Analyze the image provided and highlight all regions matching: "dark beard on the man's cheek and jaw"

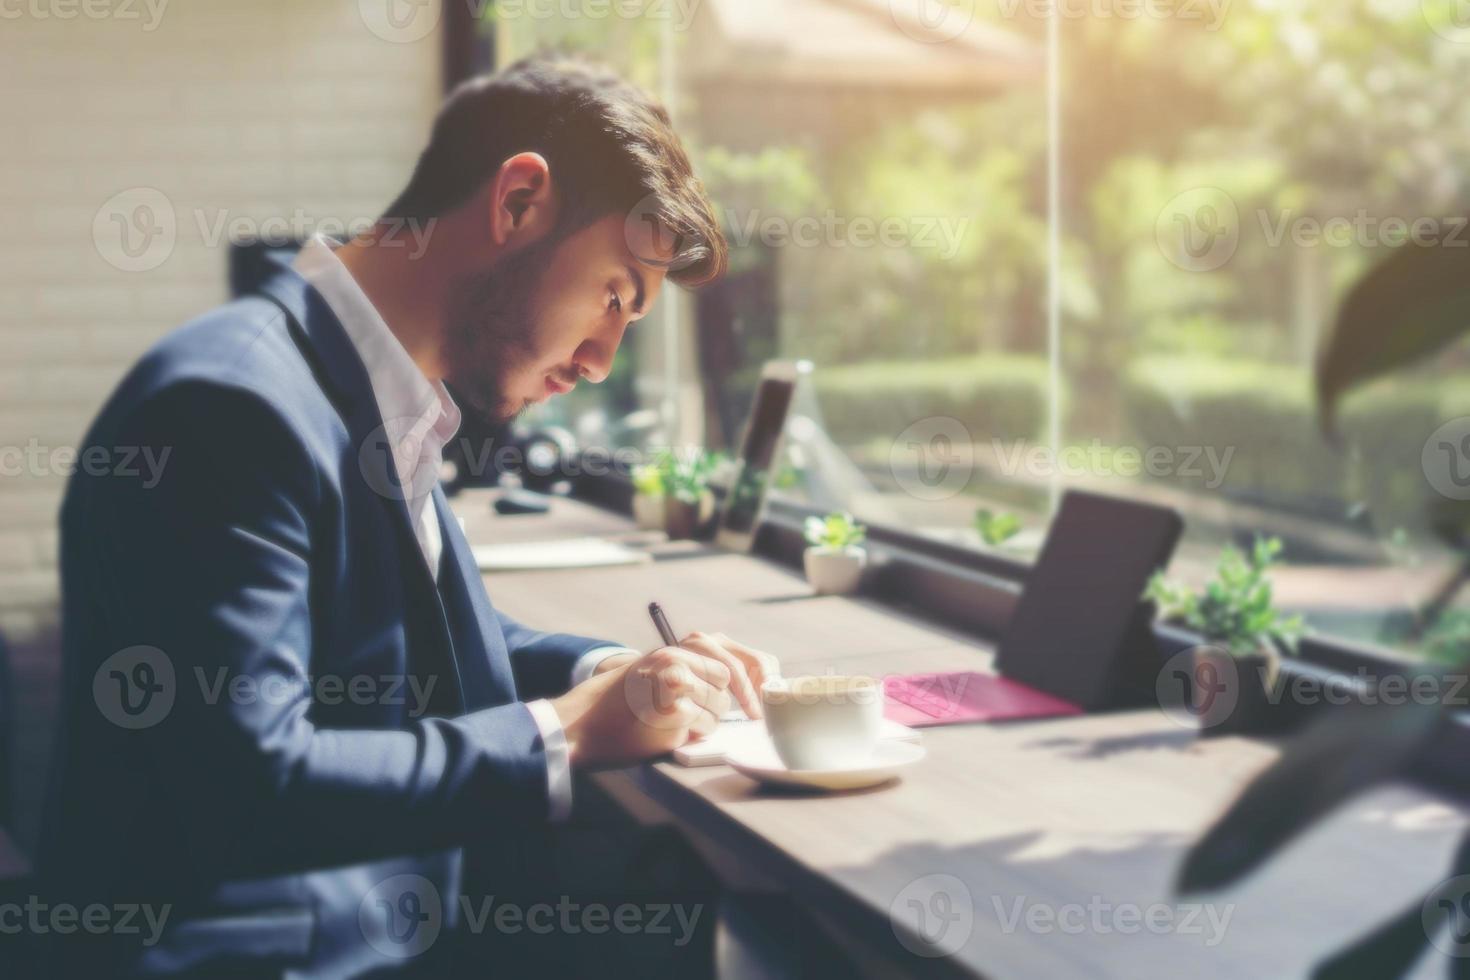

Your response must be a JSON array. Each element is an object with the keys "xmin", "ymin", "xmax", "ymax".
[{"xmin": 445, "ymin": 239, "xmax": 556, "ymax": 425}]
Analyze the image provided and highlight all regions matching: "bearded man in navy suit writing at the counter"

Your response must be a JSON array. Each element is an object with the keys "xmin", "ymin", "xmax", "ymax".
[{"xmin": 41, "ymin": 63, "xmax": 773, "ymax": 977}]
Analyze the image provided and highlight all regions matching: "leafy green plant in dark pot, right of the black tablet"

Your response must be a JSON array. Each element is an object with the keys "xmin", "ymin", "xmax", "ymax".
[{"xmin": 1145, "ymin": 538, "xmax": 1302, "ymax": 735}]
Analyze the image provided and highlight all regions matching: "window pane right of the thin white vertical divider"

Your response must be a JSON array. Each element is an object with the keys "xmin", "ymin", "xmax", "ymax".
[{"xmin": 1060, "ymin": 0, "xmax": 1470, "ymax": 664}]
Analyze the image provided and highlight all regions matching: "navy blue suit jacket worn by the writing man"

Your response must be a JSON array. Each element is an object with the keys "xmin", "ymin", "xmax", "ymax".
[{"xmin": 41, "ymin": 262, "xmax": 604, "ymax": 977}]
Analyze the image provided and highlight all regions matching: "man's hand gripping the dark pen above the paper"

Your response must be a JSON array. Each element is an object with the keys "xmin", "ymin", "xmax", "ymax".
[{"xmin": 551, "ymin": 646, "xmax": 735, "ymax": 767}]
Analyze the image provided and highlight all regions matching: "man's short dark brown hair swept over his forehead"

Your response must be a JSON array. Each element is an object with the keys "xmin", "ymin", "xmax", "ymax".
[{"xmin": 384, "ymin": 59, "xmax": 728, "ymax": 287}]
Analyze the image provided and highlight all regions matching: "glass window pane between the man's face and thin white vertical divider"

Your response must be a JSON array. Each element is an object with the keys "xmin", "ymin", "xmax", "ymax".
[{"xmin": 681, "ymin": 0, "xmax": 1048, "ymax": 554}]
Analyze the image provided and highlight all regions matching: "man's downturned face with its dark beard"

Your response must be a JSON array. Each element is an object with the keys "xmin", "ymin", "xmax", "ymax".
[{"xmin": 435, "ymin": 215, "xmax": 664, "ymax": 422}]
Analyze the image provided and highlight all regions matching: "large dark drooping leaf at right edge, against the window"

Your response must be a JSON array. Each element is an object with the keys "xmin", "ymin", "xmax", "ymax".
[{"xmin": 1317, "ymin": 232, "xmax": 1470, "ymax": 435}]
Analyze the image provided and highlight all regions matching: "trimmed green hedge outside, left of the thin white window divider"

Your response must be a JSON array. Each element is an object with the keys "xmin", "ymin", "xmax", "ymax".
[{"xmin": 814, "ymin": 354, "xmax": 1047, "ymax": 445}]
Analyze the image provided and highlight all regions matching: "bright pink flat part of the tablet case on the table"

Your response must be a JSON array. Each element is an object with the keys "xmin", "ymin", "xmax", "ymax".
[{"xmin": 883, "ymin": 670, "xmax": 1082, "ymax": 729}]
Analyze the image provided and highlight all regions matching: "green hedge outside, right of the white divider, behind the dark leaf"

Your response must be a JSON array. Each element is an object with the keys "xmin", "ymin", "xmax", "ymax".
[{"xmin": 1123, "ymin": 357, "xmax": 1467, "ymax": 527}]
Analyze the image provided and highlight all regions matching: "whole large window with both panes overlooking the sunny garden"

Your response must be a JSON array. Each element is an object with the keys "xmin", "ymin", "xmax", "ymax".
[{"xmin": 488, "ymin": 0, "xmax": 1470, "ymax": 664}]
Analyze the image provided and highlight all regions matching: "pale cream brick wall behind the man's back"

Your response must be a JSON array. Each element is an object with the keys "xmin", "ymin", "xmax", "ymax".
[{"xmin": 0, "ymin": 0, "xmax": 441, "ymax": 840}]
